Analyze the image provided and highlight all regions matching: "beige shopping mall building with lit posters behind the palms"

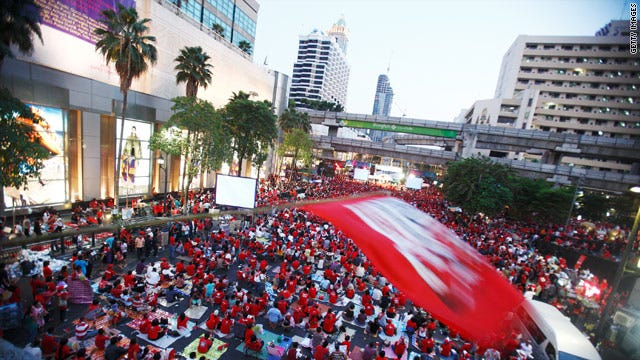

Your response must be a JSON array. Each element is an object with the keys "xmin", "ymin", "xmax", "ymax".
[{"xmin": 1, "ymin": 0, "xmax": 289, "ymax": 208}]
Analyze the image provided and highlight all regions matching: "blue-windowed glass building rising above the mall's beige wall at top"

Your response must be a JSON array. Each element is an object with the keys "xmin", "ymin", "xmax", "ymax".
[{"xmin": 169, "ymin": 0, "xmax": 260, "ymax": 52}]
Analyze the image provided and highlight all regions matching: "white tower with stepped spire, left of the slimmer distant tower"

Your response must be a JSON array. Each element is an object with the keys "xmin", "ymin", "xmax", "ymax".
[{"xmin": 289, "ymin": 18, "xmax": 349, "ymax": 106}]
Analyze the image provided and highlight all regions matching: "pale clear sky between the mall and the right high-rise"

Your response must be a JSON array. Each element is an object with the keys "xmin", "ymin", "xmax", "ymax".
[{"xmin": 254, "ymin": 0, "xmax": 630, "ymax": 121}]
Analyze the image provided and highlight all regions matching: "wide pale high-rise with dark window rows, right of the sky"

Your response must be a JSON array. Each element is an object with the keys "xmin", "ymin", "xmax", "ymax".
[{"xmin": 463, "ymin": 21, "xmax": 640, "ymax": 172}]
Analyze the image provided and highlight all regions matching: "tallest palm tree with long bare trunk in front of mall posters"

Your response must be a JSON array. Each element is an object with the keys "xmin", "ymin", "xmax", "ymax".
[{"xmin": 93, "ymin": 3, "xmax": 158, "ymax": 202}]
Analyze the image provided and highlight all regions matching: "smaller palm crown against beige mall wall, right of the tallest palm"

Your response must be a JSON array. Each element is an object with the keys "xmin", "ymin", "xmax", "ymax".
[{"xmin": 175, "ymin": 46, "xmax": 213, "ymax": 97}]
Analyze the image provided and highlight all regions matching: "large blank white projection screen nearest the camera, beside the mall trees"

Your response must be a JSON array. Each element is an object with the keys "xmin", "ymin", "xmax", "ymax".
[{"xmin": 216, "ymin": 174, "xmax": 256, "ymax": 209}]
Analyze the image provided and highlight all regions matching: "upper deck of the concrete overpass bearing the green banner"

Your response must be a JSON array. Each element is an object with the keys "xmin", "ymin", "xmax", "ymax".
[{"xmin": 300, "ymin": 109, "xmax": 640, "ymax": 162}]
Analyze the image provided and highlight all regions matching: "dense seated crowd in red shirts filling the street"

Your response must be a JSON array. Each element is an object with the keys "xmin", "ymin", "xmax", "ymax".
[{"xmin": 0, "ymin": 176, "xmax": 632, "ymax": 360}]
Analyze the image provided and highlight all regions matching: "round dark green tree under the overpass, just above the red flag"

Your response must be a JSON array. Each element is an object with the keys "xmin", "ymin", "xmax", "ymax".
[{"xmin": 443, "ymin": 157, "xmax": 514, "ymax": 216}]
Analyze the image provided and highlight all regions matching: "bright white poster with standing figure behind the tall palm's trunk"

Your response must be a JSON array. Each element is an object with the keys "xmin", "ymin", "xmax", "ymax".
[{"xmin": 116, "ymin": 120, "xmax": 151, "ymax": 196}]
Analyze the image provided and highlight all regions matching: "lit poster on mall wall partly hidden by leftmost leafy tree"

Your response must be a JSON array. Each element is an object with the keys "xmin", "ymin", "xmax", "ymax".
[{"xmin": 3, "ymin": 105, "xmax": 68, "ymax": 209}]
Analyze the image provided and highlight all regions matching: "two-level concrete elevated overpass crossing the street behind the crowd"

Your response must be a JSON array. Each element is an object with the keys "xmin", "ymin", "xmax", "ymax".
[{"xmin": 301, "ymin": 109, "xmax": 640, "ymax": 192}]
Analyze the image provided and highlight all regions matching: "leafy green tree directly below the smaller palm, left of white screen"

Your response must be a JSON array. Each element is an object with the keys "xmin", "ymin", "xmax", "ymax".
[{"xmin": 149, "ymin": 96, "xmax": 232, "ymax": 210}]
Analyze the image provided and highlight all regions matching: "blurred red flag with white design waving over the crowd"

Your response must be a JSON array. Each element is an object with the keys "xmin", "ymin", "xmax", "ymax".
[{"xmin": 303, "ymin": 196, "xmax": 523, "ymax": 344}]
